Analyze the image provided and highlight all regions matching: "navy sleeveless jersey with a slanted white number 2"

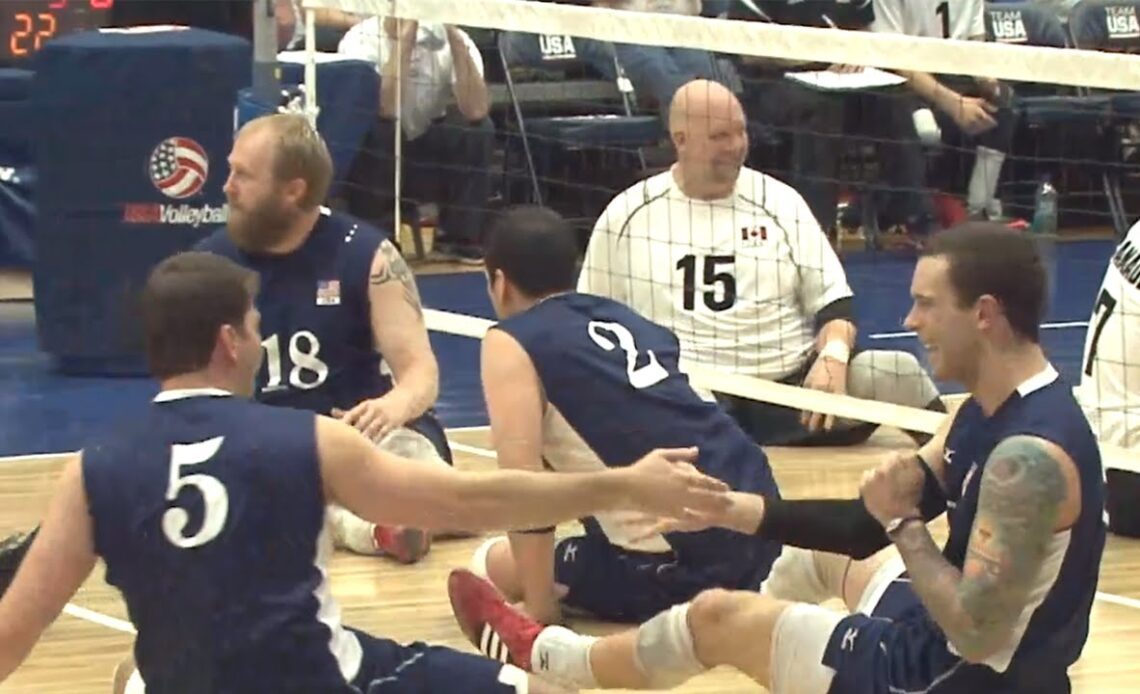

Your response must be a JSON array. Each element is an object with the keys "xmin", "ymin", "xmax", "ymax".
[{"xmin": 497, "ymin": 293, "xmax": 780, "ymax": 580}]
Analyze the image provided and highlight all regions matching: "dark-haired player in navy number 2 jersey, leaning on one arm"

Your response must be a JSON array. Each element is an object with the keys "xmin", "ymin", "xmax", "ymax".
[{"xmin": 473, "ymin": 206, "xmax": 780, "ymax": 622}]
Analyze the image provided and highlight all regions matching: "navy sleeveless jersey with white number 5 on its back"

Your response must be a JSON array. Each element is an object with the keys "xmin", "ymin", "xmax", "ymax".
[{"xmin": 82, "ymin": 390, "xmax": 361, "ymax": 694}]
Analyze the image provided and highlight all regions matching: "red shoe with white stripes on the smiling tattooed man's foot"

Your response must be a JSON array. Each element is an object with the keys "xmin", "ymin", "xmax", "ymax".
[{"xmin": 447, "ymin": 569, "xmax": 544, "ymax": 672}]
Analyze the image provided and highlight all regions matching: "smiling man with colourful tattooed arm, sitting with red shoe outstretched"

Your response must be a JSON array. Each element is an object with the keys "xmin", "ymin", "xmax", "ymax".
[{"xmin": 450, "ymin": 222, "xmax": 1105, "ymax": 694}]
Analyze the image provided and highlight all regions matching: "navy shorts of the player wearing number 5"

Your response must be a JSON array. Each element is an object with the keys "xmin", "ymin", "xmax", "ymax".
[{"xmin": 350, "ymin": 629, "xmax": 515, "ymax": 694}]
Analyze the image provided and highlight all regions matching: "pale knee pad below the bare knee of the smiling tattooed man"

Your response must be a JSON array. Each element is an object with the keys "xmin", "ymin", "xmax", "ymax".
[{"xmin": 634, "ymin": 603, "xmax": 706, "ymax": 689}]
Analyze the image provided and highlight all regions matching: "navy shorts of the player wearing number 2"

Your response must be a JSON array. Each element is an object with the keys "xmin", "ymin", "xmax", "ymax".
[{"xmin": 554, "ymin": 534, "xmax": 738, "ymax": 623}]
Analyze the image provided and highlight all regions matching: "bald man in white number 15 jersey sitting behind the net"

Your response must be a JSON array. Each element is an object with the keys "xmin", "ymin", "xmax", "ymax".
[{"xmin": 578, "ymin": 80, "xmax": 944, "ymax": 446}]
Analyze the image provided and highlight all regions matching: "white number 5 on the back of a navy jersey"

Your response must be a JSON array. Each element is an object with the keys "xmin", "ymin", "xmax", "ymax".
[{"xmin": 162, "ymin": 436, "xmax": 229, "ymax": 549}]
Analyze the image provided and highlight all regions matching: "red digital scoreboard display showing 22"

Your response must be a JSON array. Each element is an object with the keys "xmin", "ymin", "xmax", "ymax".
[{"xmin": 0, "ymin": 0, "xmax": 115, "ymax": 65}]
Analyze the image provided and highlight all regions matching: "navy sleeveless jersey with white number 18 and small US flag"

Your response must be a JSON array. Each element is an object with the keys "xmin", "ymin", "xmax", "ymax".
[{"xmin": 197, "ymin": 209, "xmax": 391, "ymax": 414}]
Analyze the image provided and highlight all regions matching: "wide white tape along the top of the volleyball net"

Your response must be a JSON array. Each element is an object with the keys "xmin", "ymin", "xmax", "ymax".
[{"xmin": 303, "ymin": 0, "xmax": 1140, "ymax": 90}]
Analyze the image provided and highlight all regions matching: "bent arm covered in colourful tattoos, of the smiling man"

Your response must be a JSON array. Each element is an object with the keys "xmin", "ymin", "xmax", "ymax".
[{"xmin": 896, "ymin": 436, "xmax": 1067, "ymax": 662}]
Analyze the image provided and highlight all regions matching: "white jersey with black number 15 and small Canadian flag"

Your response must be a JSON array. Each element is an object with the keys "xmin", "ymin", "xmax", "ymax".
[{"xmin": 578, "ymin": 168, "xmax": 852, "ymax": 378}]
